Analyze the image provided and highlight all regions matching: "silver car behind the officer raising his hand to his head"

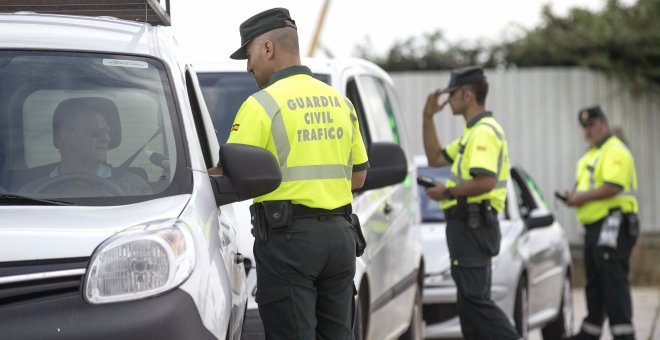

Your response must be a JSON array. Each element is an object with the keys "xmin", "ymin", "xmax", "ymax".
[{"xmin": 415, "ymin": 156, "xmax": 573, "ymax": 340}]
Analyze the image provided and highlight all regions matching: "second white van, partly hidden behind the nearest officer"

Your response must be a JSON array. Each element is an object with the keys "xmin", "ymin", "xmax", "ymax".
[{"xmin": 195, "ymin": 59, "xmax": 424, "ymax": 340}]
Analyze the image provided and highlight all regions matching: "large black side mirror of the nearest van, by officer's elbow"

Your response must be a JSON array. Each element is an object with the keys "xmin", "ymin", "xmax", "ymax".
[{"xmin": 209, "ymin": 144, "xmax": 282, "ymax": 206}]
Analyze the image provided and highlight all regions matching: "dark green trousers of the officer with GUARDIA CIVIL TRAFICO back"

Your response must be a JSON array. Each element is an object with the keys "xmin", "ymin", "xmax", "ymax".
[{"xmin": 254, "ymin": 215, "xmax": 355, "ymax": 340}]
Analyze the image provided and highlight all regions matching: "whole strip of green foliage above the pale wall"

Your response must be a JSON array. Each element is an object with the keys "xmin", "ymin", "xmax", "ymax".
[{"xmin": 357, "ymin": 0, "xmax": 660, "ymax": 90}]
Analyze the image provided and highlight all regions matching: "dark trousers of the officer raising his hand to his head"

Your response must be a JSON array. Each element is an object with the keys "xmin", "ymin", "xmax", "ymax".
[{"xmin": 447, "ymin": 219, "xmax": 520, "ymax": 340}]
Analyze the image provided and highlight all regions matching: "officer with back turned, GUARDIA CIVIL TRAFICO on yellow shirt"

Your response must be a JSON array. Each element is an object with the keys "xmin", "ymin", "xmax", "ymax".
[{"xmin": 219, "ymin": 8, "xmax": 369, "ymax": 340}]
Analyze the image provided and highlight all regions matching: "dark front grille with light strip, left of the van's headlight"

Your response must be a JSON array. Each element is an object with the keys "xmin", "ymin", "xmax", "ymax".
[{"xmin": 0, "ymin": 257, "xmax": 89, "ymax": 306}]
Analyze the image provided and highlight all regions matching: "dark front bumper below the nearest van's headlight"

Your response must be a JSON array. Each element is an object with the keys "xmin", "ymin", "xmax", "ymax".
[{"xmin": 0, "ymin": 289, "xmax": 217, "ymax": 340}]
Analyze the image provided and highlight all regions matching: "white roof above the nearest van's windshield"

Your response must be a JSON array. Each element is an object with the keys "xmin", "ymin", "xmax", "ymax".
[{"xmin": 0, "ymin": 12, "xmax": 166, "ymax": 55}]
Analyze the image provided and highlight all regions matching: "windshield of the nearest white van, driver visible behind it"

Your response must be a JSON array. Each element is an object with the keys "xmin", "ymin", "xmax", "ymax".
[{"xmin": 0, "ymin": 51, "xmax": 191, "ymax": 205}]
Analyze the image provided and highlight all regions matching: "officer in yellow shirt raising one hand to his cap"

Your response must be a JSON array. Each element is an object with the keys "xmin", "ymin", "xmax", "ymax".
[{"xmin": 423, "ymin": 66, "xmax": 520, "ymax": 340}]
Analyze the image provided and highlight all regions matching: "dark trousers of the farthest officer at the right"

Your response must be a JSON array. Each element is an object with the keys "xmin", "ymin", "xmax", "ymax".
[{"xmin": 578, "ymin": 215, "xmax": 638, "ymax": 340}]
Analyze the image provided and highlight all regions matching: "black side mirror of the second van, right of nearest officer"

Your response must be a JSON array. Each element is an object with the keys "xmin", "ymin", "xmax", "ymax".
[{"xmin": 357, "ymin": 142, "xmax": 408, "ymax": 191}]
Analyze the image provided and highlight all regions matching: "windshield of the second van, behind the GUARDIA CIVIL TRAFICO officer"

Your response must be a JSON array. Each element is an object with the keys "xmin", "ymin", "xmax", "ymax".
[{"xmin": 197, "ymin": 72, "xmax": 330, "ymax": 144}]
